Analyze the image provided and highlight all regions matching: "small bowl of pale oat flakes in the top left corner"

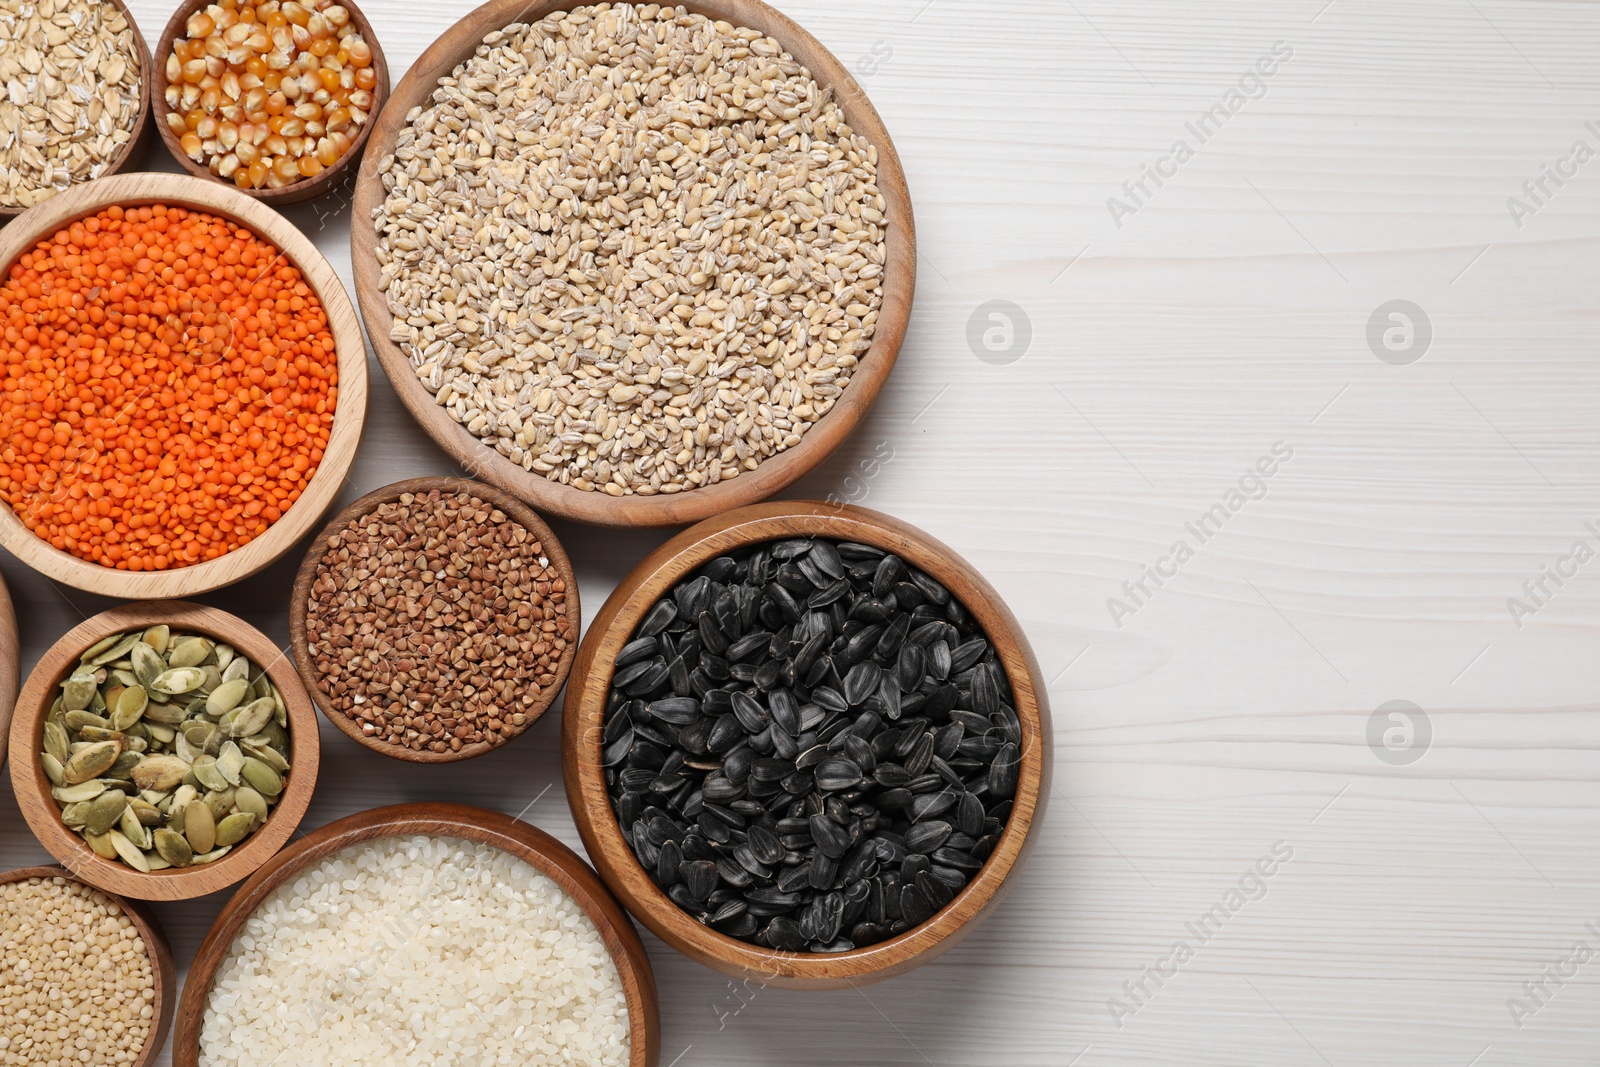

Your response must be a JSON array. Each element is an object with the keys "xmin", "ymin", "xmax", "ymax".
[{"xmin": 0, "ymin": 0, "xmax": 150, "ymax": 226}]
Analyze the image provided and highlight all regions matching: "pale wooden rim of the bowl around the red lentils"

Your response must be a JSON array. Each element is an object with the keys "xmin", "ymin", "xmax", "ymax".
[{"xmin": 0, "ymin": 174, "xmax": 366, "ymax": 600}]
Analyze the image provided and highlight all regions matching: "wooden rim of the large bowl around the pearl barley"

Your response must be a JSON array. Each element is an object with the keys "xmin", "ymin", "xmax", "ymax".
[{"xmin": 350, "ymin": 0, "xmax": 917, "ymax": 526}]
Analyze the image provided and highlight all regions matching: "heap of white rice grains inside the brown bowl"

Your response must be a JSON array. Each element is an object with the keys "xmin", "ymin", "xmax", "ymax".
[{"xmin": 200, "ymin": 837, "xmax": 629, "ymax": 1067}]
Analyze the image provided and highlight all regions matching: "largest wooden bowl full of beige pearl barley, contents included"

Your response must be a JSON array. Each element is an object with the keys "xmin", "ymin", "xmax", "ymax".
[{"xmin": 350, "ymin": 0, "xmax": 915, "ymax": 526}]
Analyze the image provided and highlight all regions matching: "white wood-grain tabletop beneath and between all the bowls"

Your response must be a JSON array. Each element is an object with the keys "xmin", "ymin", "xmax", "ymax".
[{"xmin": 0, "ymin": 0, "xmax": 1600, "ymax": 1067}]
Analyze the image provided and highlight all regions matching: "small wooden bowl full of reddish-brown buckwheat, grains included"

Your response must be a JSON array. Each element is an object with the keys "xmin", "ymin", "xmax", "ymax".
[{"xmin": 290, "ymin": 478, "xmax": 581, "ymax": 763}]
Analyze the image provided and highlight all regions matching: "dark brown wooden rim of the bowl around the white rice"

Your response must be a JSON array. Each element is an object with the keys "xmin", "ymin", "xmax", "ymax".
[{"xmin": 173, "ymin": 803, "xmax": 661, "ymax": 1067}]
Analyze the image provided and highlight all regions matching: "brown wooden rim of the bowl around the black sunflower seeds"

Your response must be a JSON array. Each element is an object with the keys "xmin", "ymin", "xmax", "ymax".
[{"xmin": 562, "ymin": 501, "xmax": 1053, "ymax": 989}]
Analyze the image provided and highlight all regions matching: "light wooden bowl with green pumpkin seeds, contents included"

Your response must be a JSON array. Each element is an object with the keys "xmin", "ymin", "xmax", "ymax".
[{"xmin": 10, "ymin": 601, "xmax": 318, "ymax": 901}]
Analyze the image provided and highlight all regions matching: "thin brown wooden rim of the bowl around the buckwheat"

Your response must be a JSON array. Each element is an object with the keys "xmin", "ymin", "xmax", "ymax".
[{"xmin": 290, "ymin": 478, "xmax": 582, "ymax": 763}]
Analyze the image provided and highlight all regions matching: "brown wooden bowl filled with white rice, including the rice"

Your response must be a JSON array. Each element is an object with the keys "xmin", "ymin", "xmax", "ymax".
[{"xmin": 173, "ymin": 803, "xmax": 659, "ymax": 1067}]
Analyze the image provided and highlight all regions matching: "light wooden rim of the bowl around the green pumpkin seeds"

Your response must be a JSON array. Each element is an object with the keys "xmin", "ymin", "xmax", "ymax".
[{"xmin": 11, "ymin": 600, "xmax": 320, "ymax": 901}]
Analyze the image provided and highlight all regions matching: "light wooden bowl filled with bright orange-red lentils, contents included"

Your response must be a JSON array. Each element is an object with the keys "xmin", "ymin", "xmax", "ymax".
[{"xmin": 0, "ymin": 174, "xmax": 366, "ymax": 600}]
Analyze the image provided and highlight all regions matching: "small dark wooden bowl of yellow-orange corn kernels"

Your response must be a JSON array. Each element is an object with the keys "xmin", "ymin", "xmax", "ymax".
[{"xmin": 150, "ymin": 0, "xmax": 389, "ymax": 203}]
